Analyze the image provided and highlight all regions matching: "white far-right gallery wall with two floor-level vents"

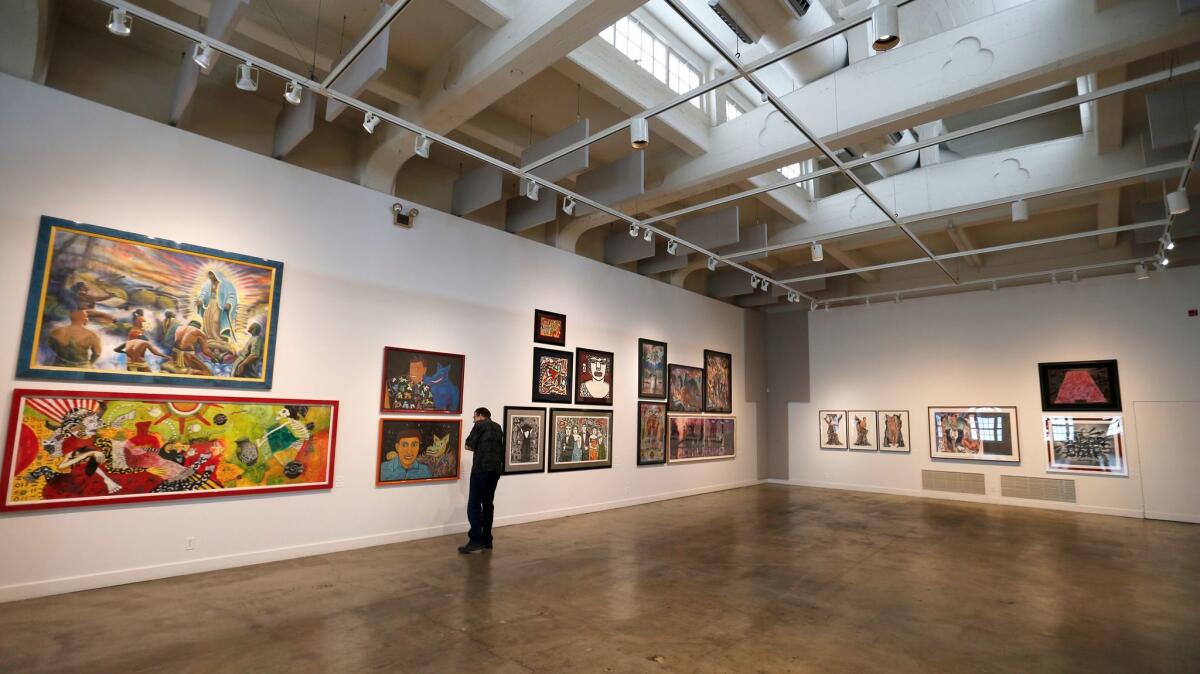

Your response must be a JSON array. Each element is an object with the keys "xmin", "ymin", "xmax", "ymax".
[{"xmin": 788, "ymin": 267, "xmax": 1200, "ymax": 522}]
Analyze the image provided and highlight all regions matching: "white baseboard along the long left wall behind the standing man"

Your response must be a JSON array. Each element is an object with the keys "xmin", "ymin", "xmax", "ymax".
[{"xmin": 0, "ymin": 480, "xmax": 762, "ymax": 603}]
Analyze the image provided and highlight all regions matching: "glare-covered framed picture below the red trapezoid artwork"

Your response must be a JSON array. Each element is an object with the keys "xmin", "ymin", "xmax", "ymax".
[{"xmin": 1043, "ymin": 415, "xmax": 1129, "ymax": 475}]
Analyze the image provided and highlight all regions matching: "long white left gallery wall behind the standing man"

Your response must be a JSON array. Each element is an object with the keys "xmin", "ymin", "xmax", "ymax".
[{"xmin": 0, "ymin": 76, "xmax": 757, "ymax": 601}]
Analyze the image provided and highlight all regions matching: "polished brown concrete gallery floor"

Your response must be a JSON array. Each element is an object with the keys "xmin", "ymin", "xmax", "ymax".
[{"xmin": 0, "ymin": 483, "xmax": 1200, "ymax": 674}]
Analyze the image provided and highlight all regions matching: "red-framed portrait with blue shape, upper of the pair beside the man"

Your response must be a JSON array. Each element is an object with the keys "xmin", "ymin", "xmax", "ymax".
[{"xmin": 379, "ymin": 347, "xmax": 467, "ymax": 414}]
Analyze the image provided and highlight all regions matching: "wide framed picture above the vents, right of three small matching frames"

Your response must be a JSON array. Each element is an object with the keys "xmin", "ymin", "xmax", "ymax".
[{"xmin": 929, "ymin": 405, "xmax": 1021, "ymax": 463}]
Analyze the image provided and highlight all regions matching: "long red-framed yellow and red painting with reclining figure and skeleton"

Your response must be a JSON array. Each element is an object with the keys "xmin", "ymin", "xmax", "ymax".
[{"xmin": 0, "ymin": 389, "xmax": 337, "ymax": 511}]
